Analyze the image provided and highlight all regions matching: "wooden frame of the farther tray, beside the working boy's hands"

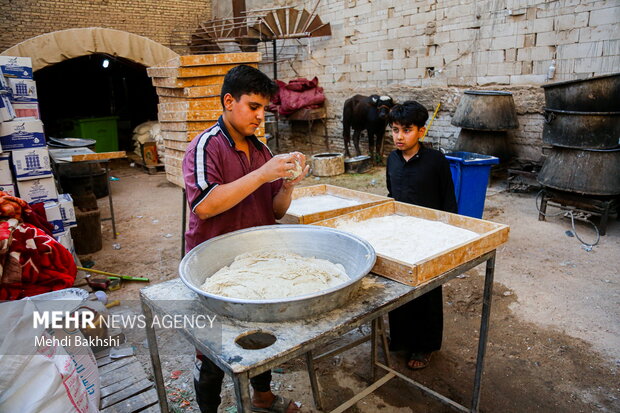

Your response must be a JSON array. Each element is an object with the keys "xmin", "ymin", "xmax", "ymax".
[{"xmin": 278, "ymin": 184, "xmax": 392, "ymax": 224}]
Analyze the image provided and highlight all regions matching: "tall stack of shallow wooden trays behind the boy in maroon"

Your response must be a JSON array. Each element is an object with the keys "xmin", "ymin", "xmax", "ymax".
[{"xmin": 147, "ymin": 53, "xmax": 265, "ymax": 187}]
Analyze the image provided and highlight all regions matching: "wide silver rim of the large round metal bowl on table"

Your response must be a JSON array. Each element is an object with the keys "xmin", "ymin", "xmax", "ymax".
[{"xmin": 179, "ymin": 224, "xmax": 377, "ymax": 304}]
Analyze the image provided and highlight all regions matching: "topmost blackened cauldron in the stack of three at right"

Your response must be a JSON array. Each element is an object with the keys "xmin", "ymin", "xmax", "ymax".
[{"xmin": 542, "ymin": 73, "xmax": 620, "ymax": 112}]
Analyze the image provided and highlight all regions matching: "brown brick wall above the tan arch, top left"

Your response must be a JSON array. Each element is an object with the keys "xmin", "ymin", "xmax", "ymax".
[{"xmin": 0, "ymin": 0, "xmax": 211, "ymax": 53}]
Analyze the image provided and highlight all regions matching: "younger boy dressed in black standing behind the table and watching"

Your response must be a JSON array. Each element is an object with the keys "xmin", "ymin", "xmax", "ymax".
[{"xmin": 386, "ymin": 101, "xmax": 457, "ymax": 370}]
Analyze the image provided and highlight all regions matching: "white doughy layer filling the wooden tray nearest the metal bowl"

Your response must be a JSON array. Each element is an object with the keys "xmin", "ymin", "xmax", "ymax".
[{"xmin": 336, "ymin": 215, "xmax": 478, "ymax": 264}]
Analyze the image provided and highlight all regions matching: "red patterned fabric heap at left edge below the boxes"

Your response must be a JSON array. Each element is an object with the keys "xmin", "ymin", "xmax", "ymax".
[{"xmin": 0, "ymin": 191, "xmax": 77, "ymax": 300}]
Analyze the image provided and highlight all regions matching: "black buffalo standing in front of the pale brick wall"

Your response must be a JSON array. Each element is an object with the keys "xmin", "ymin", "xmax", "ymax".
[{"xmin": 342, "ymin": 95, "xmax": 394, "ymax": 161}]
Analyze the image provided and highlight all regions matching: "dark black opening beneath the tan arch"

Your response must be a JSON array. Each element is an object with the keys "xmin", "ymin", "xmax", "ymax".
[{"xmin": 34, "ymin": 53, "xmax": 157, "ymax": 151}]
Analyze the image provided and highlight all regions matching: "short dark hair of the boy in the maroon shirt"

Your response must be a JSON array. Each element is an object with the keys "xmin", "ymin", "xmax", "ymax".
[{"xmin": 220, "ymin": 65, "xmax": 278, "ymax": 107}]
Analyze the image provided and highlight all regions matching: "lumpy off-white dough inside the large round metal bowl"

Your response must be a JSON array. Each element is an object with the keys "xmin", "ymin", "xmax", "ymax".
[{"xmin": 200, "ymin": 251, "xmax": 349, "ymax": 300}]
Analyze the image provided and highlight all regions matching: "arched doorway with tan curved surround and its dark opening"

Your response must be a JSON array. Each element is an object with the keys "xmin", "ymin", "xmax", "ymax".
[{"xmin": 0, "ymin": 27, "xmax": 178, "ymax": 151}]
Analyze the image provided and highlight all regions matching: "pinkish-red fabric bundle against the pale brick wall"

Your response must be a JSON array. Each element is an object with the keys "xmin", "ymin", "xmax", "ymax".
[{"xmin": 272, "ymin": 77, "xmax": 325, "ymax": 116}]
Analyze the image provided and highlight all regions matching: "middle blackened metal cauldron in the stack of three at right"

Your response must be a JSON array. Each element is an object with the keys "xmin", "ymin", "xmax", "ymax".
[{"xmin": 543, "ymin": 108, "xmax": 620, "ymax": 149}]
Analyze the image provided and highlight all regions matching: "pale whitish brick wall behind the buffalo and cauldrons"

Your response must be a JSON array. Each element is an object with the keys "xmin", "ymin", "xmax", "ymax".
[{"xmin": 253, "ymin": 0, "xmax": 620, "ymax": 160}]
